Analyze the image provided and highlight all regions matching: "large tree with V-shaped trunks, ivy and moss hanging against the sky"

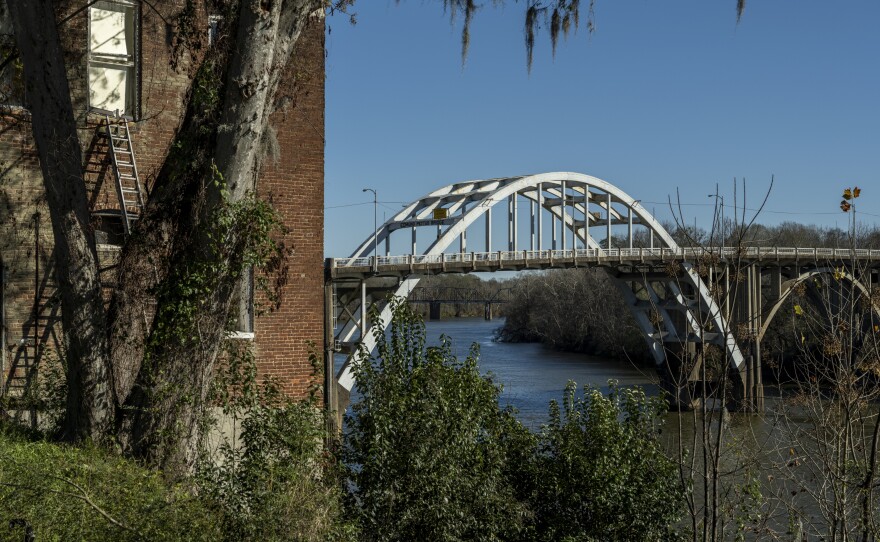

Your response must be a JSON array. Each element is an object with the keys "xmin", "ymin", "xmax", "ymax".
[{"xmin": 0, "ymin": 0, "xmax": 743, "ymax": 476}]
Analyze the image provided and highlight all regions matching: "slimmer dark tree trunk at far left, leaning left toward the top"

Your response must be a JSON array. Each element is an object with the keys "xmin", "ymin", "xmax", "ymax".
[{"xmin": 7, "ymin": 0, "xmax": 113, "ymax": 440}]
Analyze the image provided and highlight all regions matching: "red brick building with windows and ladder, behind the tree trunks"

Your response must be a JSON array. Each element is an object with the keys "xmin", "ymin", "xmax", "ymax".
[{"xmin": 0, "ymin": 0, "xmax": 324, "ymax": 404}]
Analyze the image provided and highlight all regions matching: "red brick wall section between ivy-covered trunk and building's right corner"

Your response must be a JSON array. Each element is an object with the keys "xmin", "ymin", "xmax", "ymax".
[{"xmin": 255, "ymin": 17, "xmax": 324, "ymax": 396}]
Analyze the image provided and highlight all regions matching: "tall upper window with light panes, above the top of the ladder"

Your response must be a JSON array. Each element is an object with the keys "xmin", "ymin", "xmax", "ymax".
[{"xmin": 86, "ymin": 0, "xmax": 142, "ymax": 121}]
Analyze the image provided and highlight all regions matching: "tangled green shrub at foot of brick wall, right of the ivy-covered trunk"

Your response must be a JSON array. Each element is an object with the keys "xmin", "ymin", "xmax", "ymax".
[{"xmin": 198, "ymin": 343, "xmax": 354, "ymax": 541}]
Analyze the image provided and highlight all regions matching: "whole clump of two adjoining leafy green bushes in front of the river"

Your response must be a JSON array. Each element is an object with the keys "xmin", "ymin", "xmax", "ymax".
[{"xmin": 344, "ymin": 305, "xmax": 682, "ymax": 541}]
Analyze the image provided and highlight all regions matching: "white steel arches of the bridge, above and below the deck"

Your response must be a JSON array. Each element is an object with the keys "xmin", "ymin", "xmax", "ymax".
[{"xmin": 336, "ymin": 172, "xmax": 743, "ymax": 396}]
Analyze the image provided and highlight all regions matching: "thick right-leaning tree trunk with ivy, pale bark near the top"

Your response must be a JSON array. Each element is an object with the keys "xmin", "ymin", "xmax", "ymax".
[{"xmin": 124, "ymin": 0, "xmax": 321, "ymax": 475}]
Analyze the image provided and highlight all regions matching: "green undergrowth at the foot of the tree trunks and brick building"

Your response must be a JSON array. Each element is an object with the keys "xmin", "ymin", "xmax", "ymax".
[{"xmin": 0, "ymin": 343, "xmax": 356, "ymax": 542}]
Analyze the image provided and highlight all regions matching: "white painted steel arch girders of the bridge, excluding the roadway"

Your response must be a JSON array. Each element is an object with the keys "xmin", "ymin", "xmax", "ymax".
[{"xmin": 337, "ymin": 172, "xmax": 743, "ymax": 390}]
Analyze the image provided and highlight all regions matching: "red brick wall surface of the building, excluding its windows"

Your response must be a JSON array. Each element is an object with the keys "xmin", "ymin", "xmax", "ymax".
[{"xmin": 0, "ymin": 0, "xmax": 324, "ymax": 402}]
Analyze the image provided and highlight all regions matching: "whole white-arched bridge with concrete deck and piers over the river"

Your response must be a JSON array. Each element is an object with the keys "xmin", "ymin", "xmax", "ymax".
[{"xmin": 325, "ymin": 172, "xmax": 880, "ymax": 410}]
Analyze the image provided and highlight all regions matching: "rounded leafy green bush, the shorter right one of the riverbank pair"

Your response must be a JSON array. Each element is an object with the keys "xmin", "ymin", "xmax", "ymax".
[{"xmin": 530, "ymin": 382, "xmax": 682, "ymax": 541}]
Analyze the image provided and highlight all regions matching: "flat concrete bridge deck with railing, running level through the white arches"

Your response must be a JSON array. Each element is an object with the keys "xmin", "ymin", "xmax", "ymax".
[{"xmin": 326, "ymin": 247, "xmax": 880, "ymax": 280}]
